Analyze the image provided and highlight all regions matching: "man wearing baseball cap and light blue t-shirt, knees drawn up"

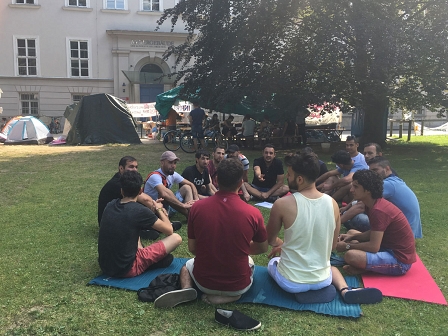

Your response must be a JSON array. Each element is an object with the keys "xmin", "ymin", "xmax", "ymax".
[{"xmin": 143, "ymin": 151, "xmax": 199, "ymax": 216}]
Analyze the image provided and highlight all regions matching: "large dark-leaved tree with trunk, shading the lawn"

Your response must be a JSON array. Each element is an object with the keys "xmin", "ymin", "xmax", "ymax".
[{"xmin": 159, "ymin": 0, "xmax": 448, "ymax": 143}]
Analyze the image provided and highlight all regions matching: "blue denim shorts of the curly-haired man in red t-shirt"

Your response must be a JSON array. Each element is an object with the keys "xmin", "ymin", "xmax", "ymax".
[{"xmin": 366, "ymin": 250, "xmax": 412, "ymax": 275}]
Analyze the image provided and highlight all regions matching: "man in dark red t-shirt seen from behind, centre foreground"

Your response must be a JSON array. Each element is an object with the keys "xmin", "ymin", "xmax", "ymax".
[{"xmin": 155, "ymin": 158, "xmax": 268, "ymax": 307}]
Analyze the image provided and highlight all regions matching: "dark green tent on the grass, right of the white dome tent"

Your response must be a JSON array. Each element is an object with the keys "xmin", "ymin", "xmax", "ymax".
[{"xmin": 64, "ymin": 93, "xmax": 141, "ymax": 145}]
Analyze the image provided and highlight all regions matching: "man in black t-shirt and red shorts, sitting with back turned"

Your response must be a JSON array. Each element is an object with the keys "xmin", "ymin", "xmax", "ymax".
[{"xmin": 98, "ymin": 171, "xmax": 182, "ymax": 278}]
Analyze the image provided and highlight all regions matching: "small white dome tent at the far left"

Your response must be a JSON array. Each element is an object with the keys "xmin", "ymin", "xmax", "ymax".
[{"xmin": 5, "ymin": 116, "xmax": 53, "ymax": 145}]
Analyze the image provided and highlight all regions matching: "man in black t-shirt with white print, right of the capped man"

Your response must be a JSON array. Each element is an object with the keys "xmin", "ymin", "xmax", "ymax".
[{"xmin": 182, "ymin": 150, "xmax": 215, "ymax": 199}]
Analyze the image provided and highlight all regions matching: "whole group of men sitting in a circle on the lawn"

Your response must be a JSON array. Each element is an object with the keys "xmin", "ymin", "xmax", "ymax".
[{"xmin": 98, "ymin": 137, "xmax": 422, "ymax": 307}]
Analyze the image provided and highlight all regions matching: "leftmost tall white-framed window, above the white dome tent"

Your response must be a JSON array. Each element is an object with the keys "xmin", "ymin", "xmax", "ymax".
[{"xmin": 16, "ymin": 38, "xmax": 37, "ymax": 76}]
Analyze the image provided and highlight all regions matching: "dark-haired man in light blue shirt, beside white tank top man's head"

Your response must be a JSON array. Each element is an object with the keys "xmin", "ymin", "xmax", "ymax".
[{"xmin": 316, "ymin": 150, "xmax": 369, "ymax": 203}]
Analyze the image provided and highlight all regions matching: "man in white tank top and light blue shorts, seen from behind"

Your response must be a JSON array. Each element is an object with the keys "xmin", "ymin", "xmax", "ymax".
[{"xmin": 266, "ymin": 153, "xmax": 382, "ymax": 303}]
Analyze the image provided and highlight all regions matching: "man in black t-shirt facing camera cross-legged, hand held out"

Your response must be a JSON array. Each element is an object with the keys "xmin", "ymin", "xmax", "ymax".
[{"xmin": 244, "ymin": 144, "xmax": 289, "ymax": 201}]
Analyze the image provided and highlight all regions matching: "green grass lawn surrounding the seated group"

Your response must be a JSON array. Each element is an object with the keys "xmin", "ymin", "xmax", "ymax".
[{"xmin": 0, "ymin": 136, "xmax": 448, "ymax": 336}]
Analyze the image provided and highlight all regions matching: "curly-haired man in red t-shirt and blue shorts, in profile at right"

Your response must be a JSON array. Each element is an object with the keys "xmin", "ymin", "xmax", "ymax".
[{"xmin": 336, "ymin": 170, "xmax": 416, "ymax": 275}]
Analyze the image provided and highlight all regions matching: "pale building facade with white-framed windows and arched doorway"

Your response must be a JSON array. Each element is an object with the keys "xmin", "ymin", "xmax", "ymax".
[{"xmin": 0, "ymin": 0, "xmax": 187, "ymax": 117}]
